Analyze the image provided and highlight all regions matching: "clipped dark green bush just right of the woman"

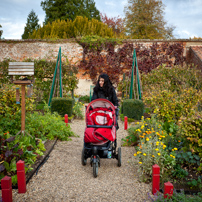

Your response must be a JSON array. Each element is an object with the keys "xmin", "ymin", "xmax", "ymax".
[{"xmin": 123, "ymin": 99, "xmax": 144, "ymax": 120}]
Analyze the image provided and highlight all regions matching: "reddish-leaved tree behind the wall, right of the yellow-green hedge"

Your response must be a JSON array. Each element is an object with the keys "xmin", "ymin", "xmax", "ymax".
[{"xmin": 100, "ymin": 13, "xmax": 125, "ymax": 37}]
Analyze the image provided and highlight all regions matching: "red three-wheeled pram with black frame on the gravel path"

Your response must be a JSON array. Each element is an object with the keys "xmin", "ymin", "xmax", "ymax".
[{"xmin": 81, "ymin": 99, "xmax": 121, "ymax": 177}]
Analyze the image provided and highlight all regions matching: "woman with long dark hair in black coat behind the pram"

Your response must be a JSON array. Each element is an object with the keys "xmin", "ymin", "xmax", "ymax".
[{"xmin": 91, "ymin": 73, "xmax": 118, "ymax": 107}]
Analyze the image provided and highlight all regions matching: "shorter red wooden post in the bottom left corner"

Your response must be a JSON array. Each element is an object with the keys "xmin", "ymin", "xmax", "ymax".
[{"xmin": 1, "ymin": 176, "xmax": 13, "ymax": 202}]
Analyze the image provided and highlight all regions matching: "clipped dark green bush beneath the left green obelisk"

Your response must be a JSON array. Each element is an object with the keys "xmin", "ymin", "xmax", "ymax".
[{"xmin": 51, "ymin": 98, "xmax": 74, "ymax": 117}]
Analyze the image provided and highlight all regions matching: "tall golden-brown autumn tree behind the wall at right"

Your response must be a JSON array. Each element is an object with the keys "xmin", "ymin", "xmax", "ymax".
[{"xmin": 124, "ymin": 0, "xmax": 174, "ymax": 39}]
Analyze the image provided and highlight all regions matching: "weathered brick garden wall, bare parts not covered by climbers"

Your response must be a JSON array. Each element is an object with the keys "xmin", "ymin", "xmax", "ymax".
[{"xmin": 0, "ymin": 39, "xmax": 202, "ymax": 95}]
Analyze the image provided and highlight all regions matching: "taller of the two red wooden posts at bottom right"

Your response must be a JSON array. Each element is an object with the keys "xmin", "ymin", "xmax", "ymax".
[{"xmin": 152, "ymin": 164, "xmax": 160, "ymax": 195}]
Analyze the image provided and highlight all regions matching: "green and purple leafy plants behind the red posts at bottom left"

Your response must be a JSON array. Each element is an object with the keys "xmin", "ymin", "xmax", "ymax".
[{"xmin": 0, "ymin": 132, "xmax": 45, "ymax": 185}]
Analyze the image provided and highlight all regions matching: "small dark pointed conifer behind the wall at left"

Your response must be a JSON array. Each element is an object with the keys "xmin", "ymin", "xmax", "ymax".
[{"xmin": 22, "ymin": 10, "xmax": 39, "ymax": 39}]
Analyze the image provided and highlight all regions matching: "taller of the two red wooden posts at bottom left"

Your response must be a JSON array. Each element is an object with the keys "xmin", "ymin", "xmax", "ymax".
[{"xmin": 16, "ymin": 160, "xmax": 26, "ymax": 193}]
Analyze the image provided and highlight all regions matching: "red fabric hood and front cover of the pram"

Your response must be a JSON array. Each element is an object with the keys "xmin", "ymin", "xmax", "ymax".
[{"xmin": 84, "ymin": 98, "xmax": 116, "ymax": 145}]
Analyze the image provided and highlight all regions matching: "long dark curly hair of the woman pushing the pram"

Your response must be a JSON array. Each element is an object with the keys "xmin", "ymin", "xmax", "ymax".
[{"xmin": 94, "ymin": 73, "xmax": 113, "ymax": 97}]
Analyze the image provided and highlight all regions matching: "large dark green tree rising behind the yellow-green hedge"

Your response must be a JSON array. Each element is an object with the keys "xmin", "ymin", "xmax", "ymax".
[{"xmin": 41, "ymin": 0, "xmax": 100, "ymax": 24}]
